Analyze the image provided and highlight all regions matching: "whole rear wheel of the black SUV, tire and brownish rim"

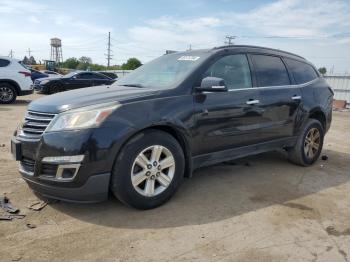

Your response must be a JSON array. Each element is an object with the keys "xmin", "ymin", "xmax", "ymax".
[{"xmin": 288, "ymin": 119, "xmax": 324, "ymax": 166}]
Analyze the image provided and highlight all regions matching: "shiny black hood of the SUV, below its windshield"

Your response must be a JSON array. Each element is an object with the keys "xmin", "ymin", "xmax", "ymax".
[{"xmin": 28, "ymin": 85, "xmax": 157, "ymax": 113}]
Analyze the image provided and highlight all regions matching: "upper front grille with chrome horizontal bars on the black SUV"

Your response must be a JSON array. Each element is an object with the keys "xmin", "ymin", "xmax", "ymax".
[{"xmin": 20, "ymin": 111, "xmax": 55, "ymax": 139}]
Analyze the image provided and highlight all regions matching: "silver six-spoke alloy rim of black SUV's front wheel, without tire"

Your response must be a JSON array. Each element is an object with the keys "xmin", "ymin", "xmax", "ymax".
[{"xmin": 131, "ymin": 145, "xmax": 175, "ymax": 197}]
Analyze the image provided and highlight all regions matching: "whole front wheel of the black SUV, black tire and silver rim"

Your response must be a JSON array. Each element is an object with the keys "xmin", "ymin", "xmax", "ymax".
[{"xmin": 111, "ymin": 130, "xmax": 185, "ymax": 209}]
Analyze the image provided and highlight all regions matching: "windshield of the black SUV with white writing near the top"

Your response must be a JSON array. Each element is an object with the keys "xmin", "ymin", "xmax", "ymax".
[{"xmin": 115, "ymin": 51, "xmax": 210, "ymax": 89}]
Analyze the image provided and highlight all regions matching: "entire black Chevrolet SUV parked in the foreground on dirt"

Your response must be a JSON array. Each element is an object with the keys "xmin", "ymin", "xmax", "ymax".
[{"xmin": 12, "ymin": 46, "xmax": 333, "ymax": 209}]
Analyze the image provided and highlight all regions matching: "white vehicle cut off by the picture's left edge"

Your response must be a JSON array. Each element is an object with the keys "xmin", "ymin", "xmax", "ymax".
[{"xmin": 0, "ymin": 57, "xmax": 33, "ymax": 104}]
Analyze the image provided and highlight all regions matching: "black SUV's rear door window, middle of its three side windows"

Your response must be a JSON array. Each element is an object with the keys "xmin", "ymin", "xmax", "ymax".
[{"xmin": 252, "ymin": 55, "xmax": 290, "ymax": 86}]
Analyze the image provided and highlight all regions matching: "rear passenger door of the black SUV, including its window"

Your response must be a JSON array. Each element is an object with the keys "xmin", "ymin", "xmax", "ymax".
[{"xmin": 250, "ymin": 54, "xmax": 301, "ymax": 141}]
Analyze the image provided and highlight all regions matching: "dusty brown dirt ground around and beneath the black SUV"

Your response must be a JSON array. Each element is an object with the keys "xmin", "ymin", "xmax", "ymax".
[{"xmin": 0, "ymin": 95, "xmax": 350, "ymax": 262}]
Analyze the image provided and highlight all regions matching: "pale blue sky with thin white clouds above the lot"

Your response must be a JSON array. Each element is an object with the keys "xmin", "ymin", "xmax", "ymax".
[{"xmin": 0, "ymin": 0, "xmax": 350, "ymax": 74}]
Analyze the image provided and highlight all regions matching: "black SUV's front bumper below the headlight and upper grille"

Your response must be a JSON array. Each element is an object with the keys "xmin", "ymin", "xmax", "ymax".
[{"xmin": 11, "ymin": 128, "xmax": 127, "ymax": 202}]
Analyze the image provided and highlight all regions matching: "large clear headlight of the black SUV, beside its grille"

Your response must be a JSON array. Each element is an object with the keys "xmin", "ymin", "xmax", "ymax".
[{"xmin": 46, "ymin": 103, "xmax": 120, "ymax": 132}]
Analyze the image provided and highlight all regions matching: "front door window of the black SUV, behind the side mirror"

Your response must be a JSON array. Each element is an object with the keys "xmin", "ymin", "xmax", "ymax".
[{"xmin": 204, "ymin": 54, "xmax": 252, "ymax": 89}]
